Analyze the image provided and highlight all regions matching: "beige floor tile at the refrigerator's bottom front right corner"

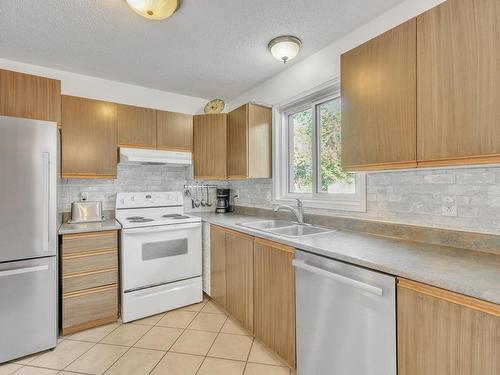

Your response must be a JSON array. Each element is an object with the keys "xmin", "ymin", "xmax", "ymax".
[{"xmin": 30, "ymin": 340, "xmax": 94, "ymax": 370}]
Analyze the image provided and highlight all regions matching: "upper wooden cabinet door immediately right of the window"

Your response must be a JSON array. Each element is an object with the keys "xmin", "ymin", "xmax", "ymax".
[{"xmin": 341, "ymin": 19, "xmax": 417, "ymax": 170}]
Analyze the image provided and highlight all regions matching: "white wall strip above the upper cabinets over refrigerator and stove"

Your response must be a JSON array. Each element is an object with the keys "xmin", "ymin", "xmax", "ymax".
[{"xmin": 0, "ymin": 59, "xmax": 208, "ymax": 114}]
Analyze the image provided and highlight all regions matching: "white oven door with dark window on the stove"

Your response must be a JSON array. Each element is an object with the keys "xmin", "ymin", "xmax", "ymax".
[{"xmin": 120, "ymin": 223, "xmax": 201, "ymax": 292}]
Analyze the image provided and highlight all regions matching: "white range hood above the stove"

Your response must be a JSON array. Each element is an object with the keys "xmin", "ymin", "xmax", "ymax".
[{"xmin": 120, "ymin": 147, "xmax": 192, "ymax": 165}]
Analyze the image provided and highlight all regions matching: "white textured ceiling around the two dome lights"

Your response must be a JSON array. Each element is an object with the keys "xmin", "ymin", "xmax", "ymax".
[{"xmin": 0, "ymin": 0, "xmax": 403, "ymax": 100}]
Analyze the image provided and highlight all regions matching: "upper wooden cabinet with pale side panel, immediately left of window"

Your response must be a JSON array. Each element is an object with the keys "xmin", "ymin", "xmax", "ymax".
[{"xmin": 227, "ymin": 104, "xmax": 272, "ymax": 179}]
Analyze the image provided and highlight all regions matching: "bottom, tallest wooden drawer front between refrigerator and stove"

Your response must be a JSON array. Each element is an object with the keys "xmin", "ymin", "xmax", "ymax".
[{"xmin": 62, "ymin": 285, "xmax": 118, "ymax": 329}]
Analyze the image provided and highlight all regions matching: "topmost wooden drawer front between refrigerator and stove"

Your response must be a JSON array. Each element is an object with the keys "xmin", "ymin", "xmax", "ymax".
[{"xmin": 62, "ymin": 231, "xmax": 118, "ymax": 255}]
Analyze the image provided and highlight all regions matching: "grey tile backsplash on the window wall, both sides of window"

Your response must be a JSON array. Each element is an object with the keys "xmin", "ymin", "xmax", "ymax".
[{"xmin": 229, "ymin": 167, "xmax": 500, "ymax": 234}]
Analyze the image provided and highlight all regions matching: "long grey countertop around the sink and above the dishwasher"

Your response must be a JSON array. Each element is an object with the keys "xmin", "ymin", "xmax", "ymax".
[{"xmin": 191, "ymin": 213, "xmax": 500, "ymax": 304}]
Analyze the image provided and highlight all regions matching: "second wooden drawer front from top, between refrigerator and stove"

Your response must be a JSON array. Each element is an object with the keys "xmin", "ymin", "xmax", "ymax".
[{"xmin": 62, "ymin": 250, "xmax": 118, "ymax": 276}]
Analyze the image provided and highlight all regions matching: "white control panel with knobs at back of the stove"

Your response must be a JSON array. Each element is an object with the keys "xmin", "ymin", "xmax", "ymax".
[{"xmin": 116, "ymin": 191, "xmax": 184, "ymax": 209}]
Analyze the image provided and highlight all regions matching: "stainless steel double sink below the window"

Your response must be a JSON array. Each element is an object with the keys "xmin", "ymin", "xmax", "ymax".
[{"xmin": 239, "ymin": 220, "xmax": 332, "ymax": 238}]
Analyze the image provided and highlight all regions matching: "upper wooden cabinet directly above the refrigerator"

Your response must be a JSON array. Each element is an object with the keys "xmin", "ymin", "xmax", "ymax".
[{"xmin": 0, "ymin": 69, "xmax": 61, "ymax": 124}]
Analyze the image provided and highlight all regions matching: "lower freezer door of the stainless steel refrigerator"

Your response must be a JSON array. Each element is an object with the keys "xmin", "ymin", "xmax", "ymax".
[{"xmin": 0, "ymin": 257, "xmax": 57, "ymax": 363}]
